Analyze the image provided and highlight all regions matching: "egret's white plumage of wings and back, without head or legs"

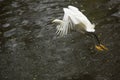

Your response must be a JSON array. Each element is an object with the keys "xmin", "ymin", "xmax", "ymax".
[{"xmin": 56, "ymin": 6, "xmax": 94, "ymax": 36}]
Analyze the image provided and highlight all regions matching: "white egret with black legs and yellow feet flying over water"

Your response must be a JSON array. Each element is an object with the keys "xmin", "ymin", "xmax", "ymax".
[{"xmin": 53, "ymin": 6, "xmax": 107, "ymax": 51}]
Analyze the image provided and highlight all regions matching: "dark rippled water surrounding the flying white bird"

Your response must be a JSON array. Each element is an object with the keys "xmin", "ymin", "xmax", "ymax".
[{"xmin": 0, "ymin": 0, "xmax": 120, "ymax": 80}]
